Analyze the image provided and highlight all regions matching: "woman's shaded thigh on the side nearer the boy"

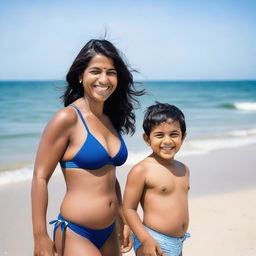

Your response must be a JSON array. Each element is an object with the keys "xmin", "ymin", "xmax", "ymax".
[{"xmin": 100, "ymin": 225, "xmax": 122, "ymax": 256}]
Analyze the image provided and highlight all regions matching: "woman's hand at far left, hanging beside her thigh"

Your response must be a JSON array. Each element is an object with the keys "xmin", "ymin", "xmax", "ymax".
[{"xmin": 34, "ymin": 236, "xmax": 57, "ymax": 256}]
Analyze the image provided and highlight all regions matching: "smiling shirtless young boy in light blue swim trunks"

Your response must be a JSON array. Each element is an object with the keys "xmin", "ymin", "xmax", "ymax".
[{"xmin": 123, "ymin": 102, "xmax": 189, "ymax": 256}]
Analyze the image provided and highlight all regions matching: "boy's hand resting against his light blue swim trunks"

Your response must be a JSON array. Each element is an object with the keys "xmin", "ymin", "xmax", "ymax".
[{"xmin": 138, "ymin": 236, "xmax": 166, "ymax": 256}]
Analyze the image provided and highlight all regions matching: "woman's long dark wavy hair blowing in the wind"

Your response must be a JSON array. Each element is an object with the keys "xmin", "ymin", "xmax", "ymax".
[{"xmin": 61, "ymin": 39, "xmax": 145, "ymax": 134}]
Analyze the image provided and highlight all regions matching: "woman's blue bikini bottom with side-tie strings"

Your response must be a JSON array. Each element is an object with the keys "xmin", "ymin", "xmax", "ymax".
[{"xmin": 49, "ymin": 214, "xmax": 115, "ymax": 249}]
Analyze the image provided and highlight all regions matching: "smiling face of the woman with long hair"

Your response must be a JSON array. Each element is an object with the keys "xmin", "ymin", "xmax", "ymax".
[{"xmin": 80, "ymin": 54, "xmax": 117, "ymax": 102}]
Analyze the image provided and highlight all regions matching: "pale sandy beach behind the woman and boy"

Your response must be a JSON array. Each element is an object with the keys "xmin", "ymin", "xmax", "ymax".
[{"xmin": 0, "ymin": 146, "xmax": 256, "ymax": 256}]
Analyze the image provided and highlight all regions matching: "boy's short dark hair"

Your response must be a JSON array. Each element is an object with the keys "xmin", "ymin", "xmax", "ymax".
[{"xmin": 143, "ymin": 102, "xmax": 186, "ymax": 138}]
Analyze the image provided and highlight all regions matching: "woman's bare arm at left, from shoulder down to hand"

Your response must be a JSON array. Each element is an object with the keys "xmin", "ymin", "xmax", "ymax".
[{"xmin": 31, "ymin": 109, "xmax": 73, "ymax": 255}]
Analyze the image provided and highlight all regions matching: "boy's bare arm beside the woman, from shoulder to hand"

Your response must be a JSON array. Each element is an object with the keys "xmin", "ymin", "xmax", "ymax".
[{"xmin": 123, "ymin": 164, "xmax": 162, "ymax": 255}]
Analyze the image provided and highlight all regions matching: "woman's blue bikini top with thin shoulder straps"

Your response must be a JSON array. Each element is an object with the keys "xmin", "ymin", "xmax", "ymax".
[{"xmin": 60, "ymin": 104, "xmax": 128, "ymax": 170}]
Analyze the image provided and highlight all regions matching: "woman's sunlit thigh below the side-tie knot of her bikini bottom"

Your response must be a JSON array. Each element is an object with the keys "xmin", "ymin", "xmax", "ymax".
[{"xmin": 55, "ymin": 228, "xmax": 102, "ymax": 256}]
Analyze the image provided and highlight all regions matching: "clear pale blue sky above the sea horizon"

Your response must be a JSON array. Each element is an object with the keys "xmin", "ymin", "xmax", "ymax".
[{"xmin": 0, "ymin": 0, "xmax": 256, "ymax": 80}]
